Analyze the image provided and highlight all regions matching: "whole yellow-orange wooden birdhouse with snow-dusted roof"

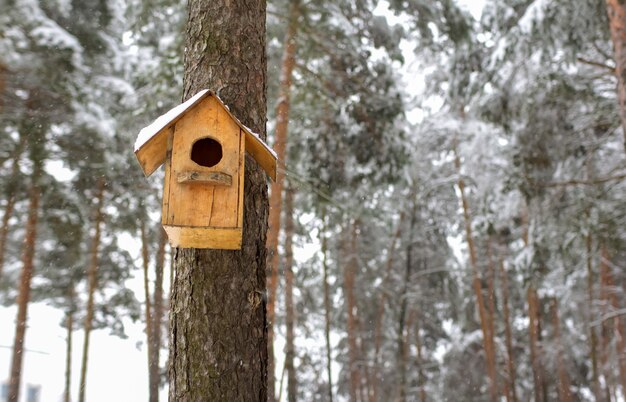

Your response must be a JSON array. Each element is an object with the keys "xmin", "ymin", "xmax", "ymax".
[{"xmin": 135, "ymin": 90, "xmax": 276, "ymax": 250}]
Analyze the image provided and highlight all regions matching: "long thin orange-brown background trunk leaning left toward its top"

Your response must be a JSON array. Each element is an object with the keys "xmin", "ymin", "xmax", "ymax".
[{"xmin": 453, "ymin": 139, "xmax": 498, "ymax": 402}]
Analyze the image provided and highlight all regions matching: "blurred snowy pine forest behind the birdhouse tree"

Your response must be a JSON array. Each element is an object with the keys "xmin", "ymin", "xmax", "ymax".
[{"xmin": 0, "ymin": 0, "xmax": 626, "ymax": 402}]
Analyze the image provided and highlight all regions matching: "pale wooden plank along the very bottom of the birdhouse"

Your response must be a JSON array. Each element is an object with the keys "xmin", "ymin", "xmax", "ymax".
[{"xmin": 163, "ymin": 225, "xmax": 243, "ymax": 250}]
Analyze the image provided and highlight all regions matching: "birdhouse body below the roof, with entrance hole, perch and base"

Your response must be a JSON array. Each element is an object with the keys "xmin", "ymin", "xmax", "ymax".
[{"xmin": 163, "ymin": 97, "xmax": 245, "ymax": 249}]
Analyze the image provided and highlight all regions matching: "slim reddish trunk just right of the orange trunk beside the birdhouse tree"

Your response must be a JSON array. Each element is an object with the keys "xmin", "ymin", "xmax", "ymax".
[{"xmin": 285, "ymin": 187, "xmax": 298, "ymax": 402}]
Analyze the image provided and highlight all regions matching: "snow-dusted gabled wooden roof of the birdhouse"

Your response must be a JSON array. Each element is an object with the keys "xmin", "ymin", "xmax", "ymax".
[{"xmin": 135, "ymin": 89, "xmax": 277, "ymax": 180}]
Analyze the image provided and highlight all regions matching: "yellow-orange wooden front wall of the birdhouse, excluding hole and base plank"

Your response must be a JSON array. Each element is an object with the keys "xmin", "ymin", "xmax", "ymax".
[{"xmin": 163, "ymin": 97, "xmax": 245, "ymax": 229}]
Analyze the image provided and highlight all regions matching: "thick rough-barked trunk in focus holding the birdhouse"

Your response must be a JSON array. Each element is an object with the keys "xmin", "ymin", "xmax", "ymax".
[{"xmin": 169, "ymin": 0, "xmax": 268, "ymax": 402}]
